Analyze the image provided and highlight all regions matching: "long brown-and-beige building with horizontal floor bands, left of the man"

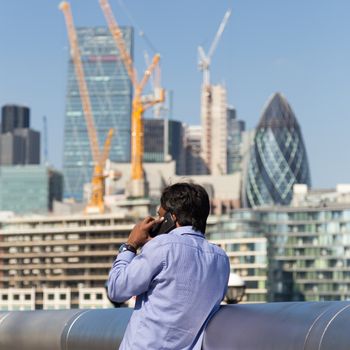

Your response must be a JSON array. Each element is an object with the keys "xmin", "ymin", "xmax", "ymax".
[{"xmin": 0, "ymin": 213, "xmax": 136, "ymax": 310}]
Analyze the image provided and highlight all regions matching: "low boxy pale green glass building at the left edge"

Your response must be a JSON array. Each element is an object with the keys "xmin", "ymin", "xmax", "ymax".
[{"xmin": 0, "ymin": 165, "xmax": 63, "ymax": 214}]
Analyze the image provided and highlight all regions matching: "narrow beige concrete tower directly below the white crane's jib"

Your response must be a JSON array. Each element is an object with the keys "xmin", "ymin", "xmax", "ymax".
[{"xmin": 201, "ymin": 85, "xmax": 227, "ymax": 175}]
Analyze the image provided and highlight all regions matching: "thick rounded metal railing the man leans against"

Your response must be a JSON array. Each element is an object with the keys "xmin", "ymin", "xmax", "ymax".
[{"xmin": 0, "ymin": 302, "xmax": 350, "ymax": 350}]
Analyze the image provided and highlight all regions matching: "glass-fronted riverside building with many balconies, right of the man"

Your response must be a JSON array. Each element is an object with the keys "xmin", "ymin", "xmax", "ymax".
[{"xmin": 213, "ymin": 186, "xmax": 350, "ymax": 302}]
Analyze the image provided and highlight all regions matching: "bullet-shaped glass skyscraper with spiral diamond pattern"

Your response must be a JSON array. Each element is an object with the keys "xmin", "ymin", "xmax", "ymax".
[{"xmin": 245, "ymin": 93, "xmax": 311, "ymax": 207}]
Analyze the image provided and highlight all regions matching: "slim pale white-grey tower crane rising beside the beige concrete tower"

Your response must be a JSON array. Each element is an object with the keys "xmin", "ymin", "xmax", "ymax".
[{"xmin": 198, "ymin": 9, "xmax": 231, "ymax": 173}]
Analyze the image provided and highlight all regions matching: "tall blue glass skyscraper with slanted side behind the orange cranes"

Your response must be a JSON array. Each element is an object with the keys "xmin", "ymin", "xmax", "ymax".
[{"xmin": 63, "ymin": 27, "xmax": 133, "ymax": 201}]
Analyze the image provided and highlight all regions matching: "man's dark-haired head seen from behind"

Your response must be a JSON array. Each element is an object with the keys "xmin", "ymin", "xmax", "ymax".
[{"xmin": 160, "ymin": 182, "xmax": 210, "ymax": 233}]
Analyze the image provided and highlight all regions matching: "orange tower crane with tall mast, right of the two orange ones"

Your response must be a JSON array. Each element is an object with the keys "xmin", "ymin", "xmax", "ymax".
[{"xmin": 99, "ymin": 0, "xmax": 164, "ymax": 197}]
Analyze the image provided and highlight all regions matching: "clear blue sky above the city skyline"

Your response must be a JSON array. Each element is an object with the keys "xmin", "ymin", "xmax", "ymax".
[{"xmin": 0, "ymin": 0, "xmax": 350, "ymax": 187}]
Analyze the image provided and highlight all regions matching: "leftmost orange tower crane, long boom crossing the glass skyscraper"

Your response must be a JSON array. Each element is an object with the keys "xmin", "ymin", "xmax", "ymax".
[{"xmin": 59, "ymin": 1, "xmax": 114, "ymax": 213}]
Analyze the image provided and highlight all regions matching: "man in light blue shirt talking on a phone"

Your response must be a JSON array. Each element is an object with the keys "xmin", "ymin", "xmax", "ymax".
[{"xmin": 108, "ymin": 183, "xmax": 230, "ymax": 350}]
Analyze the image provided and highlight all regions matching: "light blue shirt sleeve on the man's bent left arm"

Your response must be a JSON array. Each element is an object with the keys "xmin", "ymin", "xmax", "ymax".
[{"xmin": 108, "ymin": 240, "xmax": 164, "ymax": 303}]
